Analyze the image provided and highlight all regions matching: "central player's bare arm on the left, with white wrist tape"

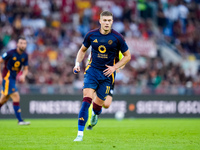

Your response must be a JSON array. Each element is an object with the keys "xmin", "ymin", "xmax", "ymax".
[{"xmin": 73, "ymin": 44, "xmax": 87, "ymax": 74}]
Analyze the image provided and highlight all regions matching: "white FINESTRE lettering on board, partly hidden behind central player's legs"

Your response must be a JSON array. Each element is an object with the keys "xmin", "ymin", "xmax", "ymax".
[{"xmin": 29, "ymin": 100, "xmax": 127, "ymax": 114}]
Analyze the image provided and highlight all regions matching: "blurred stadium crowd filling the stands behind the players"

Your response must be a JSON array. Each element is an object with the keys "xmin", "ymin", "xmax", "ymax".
[{"xmin": 0, "ymin": 0, "xmax": 200, "ymax": 94}]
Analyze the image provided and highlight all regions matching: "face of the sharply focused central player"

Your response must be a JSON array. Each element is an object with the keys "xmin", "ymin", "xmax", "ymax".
[{"xmin": 99, "ymin": 16, "xmax": 113, "ymax": 31}]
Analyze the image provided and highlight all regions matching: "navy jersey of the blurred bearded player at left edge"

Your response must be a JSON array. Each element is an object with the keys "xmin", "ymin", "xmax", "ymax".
[{"xmin": 2, "ymin": 49, "xmax": 28, "ymax": 79}]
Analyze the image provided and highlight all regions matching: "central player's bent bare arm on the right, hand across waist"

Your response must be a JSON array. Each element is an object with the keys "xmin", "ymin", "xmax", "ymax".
[{"xmin": 103, "ymin": 50, "xmax": 131, "ymax": 77}]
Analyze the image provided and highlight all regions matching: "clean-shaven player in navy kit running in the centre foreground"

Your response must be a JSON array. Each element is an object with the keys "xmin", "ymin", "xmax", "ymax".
[{"xmin": 73, "ymin": 11, "xmax": 131, "ymax": 141}]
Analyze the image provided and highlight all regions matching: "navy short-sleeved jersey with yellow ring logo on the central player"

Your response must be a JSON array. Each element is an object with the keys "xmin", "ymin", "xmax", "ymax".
[{"xmin": 83, "ymin": 29, "xmax": 128, "ymax": 70}]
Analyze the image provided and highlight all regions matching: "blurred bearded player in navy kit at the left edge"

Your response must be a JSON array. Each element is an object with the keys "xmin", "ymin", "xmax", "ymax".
[{"xmin": 0, "ymin": 37, "xmax": 30, "ymax": 125}]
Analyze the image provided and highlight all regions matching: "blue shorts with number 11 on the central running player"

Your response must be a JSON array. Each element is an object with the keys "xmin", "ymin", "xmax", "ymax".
[{"xmin": 83, "ymin": 66, "xmax": 115, "ymax": 100}]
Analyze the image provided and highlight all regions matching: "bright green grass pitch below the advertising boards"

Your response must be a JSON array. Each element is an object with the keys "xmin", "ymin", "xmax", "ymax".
[{"xmin": 0, "ymin": 118, "xmax": 200, "ymax": 150}]
